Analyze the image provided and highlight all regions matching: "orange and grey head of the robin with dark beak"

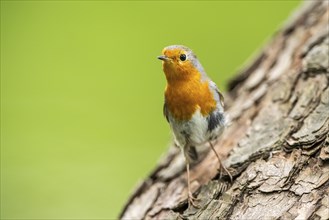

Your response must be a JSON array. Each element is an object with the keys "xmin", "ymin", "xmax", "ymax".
[{"xmin": 158, "ymin": 45, "xmax": 204, "ymax": 83}]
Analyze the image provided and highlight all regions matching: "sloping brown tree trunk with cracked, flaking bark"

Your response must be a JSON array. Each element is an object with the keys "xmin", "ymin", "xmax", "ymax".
[{"xmin": 120, "ymin": 1, "xmax": 329, "ymax": 219}]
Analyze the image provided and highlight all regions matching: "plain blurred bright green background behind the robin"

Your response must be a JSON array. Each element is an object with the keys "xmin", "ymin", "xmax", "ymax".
[{"xmin": 1, "ymin": 1, "xmax": 300, "ymax": 219}]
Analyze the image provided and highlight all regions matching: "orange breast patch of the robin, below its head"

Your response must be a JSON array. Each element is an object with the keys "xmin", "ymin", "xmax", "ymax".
[{"xmin": 165, "ymin": 72, "xmax": 216, "ymax": 121}]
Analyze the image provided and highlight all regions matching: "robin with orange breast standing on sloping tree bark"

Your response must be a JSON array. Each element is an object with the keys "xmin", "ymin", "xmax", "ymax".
[{"xmin": 157, "ymin": 45, "xmax": 232, "ymax": 207}]
